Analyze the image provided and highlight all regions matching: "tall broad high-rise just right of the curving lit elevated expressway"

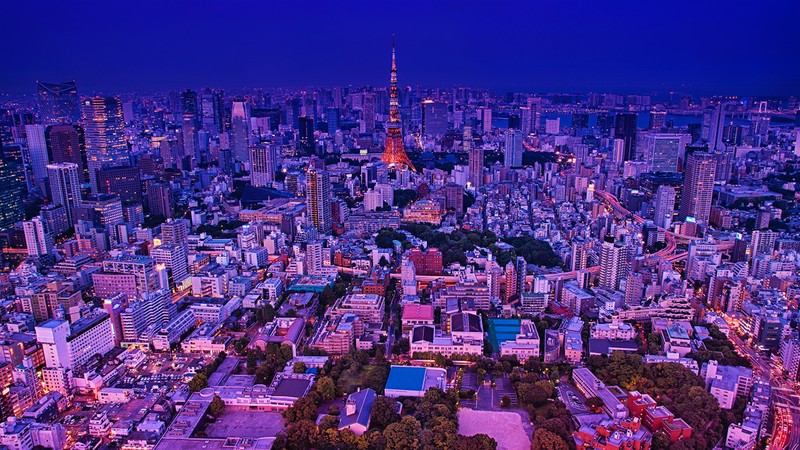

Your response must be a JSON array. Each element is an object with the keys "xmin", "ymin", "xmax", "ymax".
[{"xmin": 680, "ymin": 152, "xmax": 716, "ymax": 223}]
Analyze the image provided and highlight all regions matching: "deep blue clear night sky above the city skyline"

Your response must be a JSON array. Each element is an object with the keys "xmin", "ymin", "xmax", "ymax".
[{"xmin": 0, "ymin": 0, "xmax": 800, "ymax": 95}]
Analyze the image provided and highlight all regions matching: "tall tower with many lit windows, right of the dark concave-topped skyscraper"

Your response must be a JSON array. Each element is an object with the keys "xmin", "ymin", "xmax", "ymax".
[{"xmin": 83, "ymin": 97, "xmax": 130, "ymax": 193}]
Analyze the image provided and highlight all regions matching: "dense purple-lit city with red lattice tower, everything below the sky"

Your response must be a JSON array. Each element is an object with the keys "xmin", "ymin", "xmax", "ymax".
[{"xmin": 0, "ymin": 3, "xmax": 800, "ymax": 450}]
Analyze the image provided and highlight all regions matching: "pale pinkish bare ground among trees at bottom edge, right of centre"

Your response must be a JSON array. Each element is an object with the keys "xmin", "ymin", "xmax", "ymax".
[{"xmin": 458, "ymin": 408, "xmax": 531, "ymax": 450}]
